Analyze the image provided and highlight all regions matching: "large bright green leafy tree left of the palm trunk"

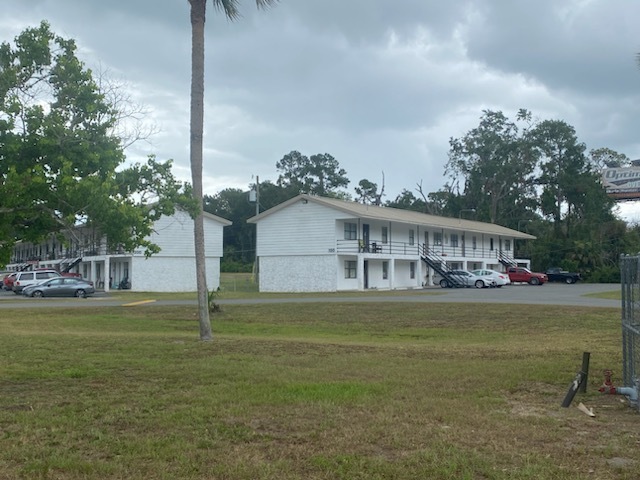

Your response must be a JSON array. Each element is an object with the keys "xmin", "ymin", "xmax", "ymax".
[{"xmin": 0, "ymin": 22, "xmax": 190, "ymax": 264}]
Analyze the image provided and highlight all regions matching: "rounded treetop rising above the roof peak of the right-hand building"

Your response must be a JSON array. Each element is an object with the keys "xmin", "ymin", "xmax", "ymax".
[{"xmin": 276, "ymin": 150, "xmax": 349, "ymax": 196}]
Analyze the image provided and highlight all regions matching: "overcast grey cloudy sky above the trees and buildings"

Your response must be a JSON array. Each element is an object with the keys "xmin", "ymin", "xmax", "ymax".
[{"xmin": 0, "ymin": 0, "xmax": 640, "ymax": 216}]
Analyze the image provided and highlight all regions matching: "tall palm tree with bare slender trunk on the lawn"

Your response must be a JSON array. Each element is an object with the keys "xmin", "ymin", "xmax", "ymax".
[{"xmin": 189, "ymin": 0, "xmax": 278, "ymax": 341}]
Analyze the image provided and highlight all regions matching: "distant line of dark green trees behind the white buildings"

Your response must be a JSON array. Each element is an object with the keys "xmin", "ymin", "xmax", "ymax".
[{"xmin": 204, "ymin": 109, "xmax": 640, "ymax": 282}]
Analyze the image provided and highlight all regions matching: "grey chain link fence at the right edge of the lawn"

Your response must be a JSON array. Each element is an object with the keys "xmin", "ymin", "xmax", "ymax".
[{"xmin": 620, "ymin": 254, "xmax": 640, "ymax": 409}]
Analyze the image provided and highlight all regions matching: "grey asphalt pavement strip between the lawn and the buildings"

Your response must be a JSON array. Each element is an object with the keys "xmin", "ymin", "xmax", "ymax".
[{"xmin": 0, "ymin": 283, "xmax": 621, "ymax": 310}]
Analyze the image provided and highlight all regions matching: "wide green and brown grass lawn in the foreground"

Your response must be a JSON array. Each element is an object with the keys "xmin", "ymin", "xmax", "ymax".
[{"xmin": 0, "ymin": 300, "xmax": 640, "ymax": 480}]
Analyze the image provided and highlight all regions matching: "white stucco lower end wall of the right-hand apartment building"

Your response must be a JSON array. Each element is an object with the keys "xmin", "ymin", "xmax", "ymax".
[{"xmin": 259, "ymin": 255, "xmax": 336, "ymax": 292}]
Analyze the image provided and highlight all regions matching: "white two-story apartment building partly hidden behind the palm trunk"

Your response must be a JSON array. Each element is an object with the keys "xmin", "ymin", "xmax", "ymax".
[{"xmin": 7, "ymin": 211, "xmax": 231, "ymax": 292}]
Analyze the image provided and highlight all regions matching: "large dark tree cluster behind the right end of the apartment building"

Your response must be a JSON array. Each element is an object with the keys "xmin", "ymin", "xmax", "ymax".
[{"xmin": 442, "ymin": 110, "xmax": 635, "ymax": 278}]
